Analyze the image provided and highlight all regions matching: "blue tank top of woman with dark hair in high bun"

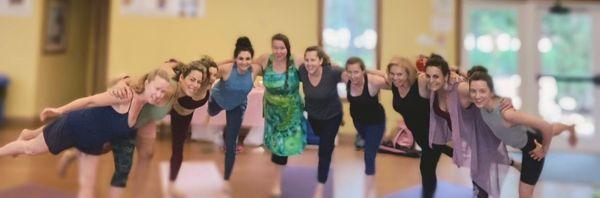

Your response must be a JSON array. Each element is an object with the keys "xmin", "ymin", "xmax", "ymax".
[{"xmin": 210, "ymin": 64, "xmax": 253, "ymax": 110}]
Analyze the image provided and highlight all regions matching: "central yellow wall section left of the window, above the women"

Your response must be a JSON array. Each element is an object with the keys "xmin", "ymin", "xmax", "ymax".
[{"xmin": 108, "ymin": 0, "xmax": 318, "ymax": 79}]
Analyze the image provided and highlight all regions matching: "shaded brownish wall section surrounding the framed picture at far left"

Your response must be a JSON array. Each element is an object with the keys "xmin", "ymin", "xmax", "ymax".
[{"xmin": 37, "ymin": 0, "xmax": 91, "ymax": 111}]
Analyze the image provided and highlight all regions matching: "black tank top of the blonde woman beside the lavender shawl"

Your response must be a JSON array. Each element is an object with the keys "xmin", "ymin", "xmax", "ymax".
[{"xmin": 392, "ymin": 82, "xmax": 429, "ymax": 147}]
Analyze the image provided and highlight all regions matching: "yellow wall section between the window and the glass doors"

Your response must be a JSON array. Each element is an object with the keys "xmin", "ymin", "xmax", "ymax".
[{"xmin": 340, "ymin": 0, "xmax": 456, "ymax": 132}]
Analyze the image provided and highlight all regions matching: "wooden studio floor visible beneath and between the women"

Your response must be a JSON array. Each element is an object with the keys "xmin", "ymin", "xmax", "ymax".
[{"xmin": 0, "ymin": 123, "xmax": 598, "ymax": 198}]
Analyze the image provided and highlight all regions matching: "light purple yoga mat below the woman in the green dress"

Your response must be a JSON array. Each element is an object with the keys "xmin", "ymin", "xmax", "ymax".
[{"xmin": 281, "ymin": 166, "xmax": 333, "ymax": 198}]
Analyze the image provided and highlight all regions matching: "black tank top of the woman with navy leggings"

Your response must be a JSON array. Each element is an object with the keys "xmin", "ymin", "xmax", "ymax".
[{"xmin": 346, "ymin": 74, "xmax": 385, "ymax": 124}]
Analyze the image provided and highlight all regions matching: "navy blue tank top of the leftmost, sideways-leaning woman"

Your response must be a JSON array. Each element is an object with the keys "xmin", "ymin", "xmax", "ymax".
[{"xmin": 64, "ymin": 106, "xmax": 135, "ymax": 154}]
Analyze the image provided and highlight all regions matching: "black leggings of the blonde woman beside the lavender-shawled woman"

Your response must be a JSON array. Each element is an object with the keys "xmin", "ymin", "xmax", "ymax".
[{"xmin": 419, "ymin": 144, "xmax": 454, "ymax": 198}]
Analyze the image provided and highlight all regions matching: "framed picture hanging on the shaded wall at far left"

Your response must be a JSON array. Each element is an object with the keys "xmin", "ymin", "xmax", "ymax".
[{"xmin": 43, "ymin": 0, "xmax": 69, "ymax": 53}]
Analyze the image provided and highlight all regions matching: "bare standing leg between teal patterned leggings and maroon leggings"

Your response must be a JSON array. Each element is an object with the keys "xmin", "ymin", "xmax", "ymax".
[{"xmin": 133, "ymin": 122, "xmax": 156, "ymax": 197}]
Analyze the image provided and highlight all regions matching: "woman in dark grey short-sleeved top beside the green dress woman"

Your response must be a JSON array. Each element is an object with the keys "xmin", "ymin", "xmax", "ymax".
[{"xmin": 298, "ymin": 46, "xmax": 344, "ymax": 197}]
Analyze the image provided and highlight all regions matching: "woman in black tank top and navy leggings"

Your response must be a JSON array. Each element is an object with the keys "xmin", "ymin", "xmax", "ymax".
[{"xmin": 344, "ymin": 57, "xmax": 387, "ymax": 197}]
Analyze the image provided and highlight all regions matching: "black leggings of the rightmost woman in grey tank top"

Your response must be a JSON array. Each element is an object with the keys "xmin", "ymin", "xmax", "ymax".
[{"xmin": 520, "ymin": 131, "xmax": 546, "ymax": 186}]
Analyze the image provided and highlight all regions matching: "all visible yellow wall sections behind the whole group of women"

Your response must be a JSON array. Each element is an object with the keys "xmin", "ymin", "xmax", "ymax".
[{"xmin": 0, "ymin": 0, "xmax": 456, "ymax": 125}]
